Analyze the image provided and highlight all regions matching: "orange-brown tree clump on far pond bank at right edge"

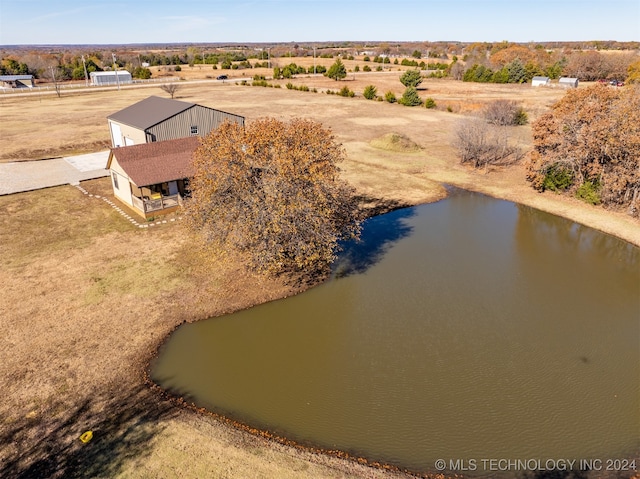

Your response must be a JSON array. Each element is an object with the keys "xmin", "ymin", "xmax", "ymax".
[{"xmin": 527, "ymin": 85, "xmax": 640, "ymax": 216}]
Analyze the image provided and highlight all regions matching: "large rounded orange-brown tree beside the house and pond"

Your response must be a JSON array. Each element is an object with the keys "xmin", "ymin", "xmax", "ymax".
[{"xmin": 186, "ymin": 118, "xmax": 360, "ymax": 274}]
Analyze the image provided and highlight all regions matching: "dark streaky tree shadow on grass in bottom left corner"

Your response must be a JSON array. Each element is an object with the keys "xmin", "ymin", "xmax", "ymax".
[{"xmin": 0, "ymin": 385, "xmax": 177, "ymax": 478}]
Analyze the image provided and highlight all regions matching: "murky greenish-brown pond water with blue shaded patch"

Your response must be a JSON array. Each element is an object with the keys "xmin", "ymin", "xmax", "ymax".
[{"xmin": 152, "ymin": 190, "xmax": 640, "ymax": 472}]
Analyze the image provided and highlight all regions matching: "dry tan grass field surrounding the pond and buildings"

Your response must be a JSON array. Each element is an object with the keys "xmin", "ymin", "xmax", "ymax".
[{"xmin": 0, "ymin": 72, "xmax": 640, "ymax": 478}]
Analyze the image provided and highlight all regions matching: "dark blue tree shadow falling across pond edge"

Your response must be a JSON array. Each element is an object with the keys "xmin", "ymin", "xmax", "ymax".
[{"xmin": 331, "ymin": 197, "xmax": 416, "ymax": 278}]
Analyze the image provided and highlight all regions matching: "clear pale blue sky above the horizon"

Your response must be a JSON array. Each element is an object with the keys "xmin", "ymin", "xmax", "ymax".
[{"xmin": 0, "ymin": 0, "xmax": 640, "ymax": 45}]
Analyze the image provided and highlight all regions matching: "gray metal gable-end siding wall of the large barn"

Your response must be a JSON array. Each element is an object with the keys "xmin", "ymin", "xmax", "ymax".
[{"xmin": 145, "ymin": 105, "xmax": 244, "ymax": 143}]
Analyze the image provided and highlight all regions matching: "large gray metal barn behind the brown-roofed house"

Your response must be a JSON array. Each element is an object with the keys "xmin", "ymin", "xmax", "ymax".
[{"xmin": 107, "ymin": 96, "xmax": 244, "ymax": 147}]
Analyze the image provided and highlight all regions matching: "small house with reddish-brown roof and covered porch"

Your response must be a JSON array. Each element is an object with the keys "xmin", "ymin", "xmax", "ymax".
[{"xmin": 107, "ymin": 136, "xmax": 200, "ymax": 218}]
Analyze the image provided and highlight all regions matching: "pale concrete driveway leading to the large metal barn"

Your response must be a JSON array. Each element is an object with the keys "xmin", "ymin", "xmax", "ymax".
[{"xmin": 0, "ymin": 150, "xmax": 109, "ymax": 195}]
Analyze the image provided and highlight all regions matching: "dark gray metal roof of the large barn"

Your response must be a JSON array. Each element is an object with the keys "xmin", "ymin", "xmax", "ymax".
[{"xmin": 107, "ymin": 96, "xmax": 195, "ymax": 130}]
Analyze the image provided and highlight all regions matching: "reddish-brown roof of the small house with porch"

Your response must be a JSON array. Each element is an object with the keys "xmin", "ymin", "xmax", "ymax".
[{"xmin": 107, "ymin": 136, "xmax": 200, "ymax": 187}]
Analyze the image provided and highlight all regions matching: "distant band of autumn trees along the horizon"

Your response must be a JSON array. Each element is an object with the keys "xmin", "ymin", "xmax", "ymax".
[{"xmin": 0, "ymin": 42, "xmax": 640, "ymax": 83}]
